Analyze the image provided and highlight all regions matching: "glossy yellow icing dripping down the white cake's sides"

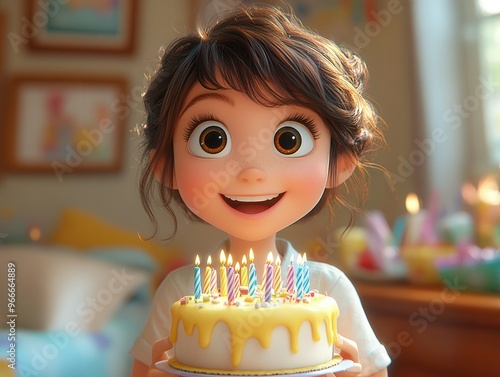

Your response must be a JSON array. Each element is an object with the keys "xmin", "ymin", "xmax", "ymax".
[{"xmin": 170, "ymin": 295, "xmax": 339, "ymax": 367}]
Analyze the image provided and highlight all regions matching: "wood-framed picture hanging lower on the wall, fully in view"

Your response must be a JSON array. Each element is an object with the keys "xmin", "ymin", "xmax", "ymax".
[{"xmin": 5, "ymin": 76, "xmax": 127, "ymax": 178}]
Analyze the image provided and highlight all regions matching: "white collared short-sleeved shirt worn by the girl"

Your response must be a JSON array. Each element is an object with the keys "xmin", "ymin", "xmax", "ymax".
[{"xmin": 130, "ymin": 240, "xmax": 391, "ymax": 376}]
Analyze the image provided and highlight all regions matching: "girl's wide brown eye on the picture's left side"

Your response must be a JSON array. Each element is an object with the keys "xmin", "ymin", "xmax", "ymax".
[{"xmin": 188, "ymin": 121, "xmax": 231, "ymax": 158}]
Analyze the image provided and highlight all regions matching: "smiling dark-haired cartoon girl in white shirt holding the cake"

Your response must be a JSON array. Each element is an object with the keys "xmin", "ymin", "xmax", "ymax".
[{"xmin": 131, "ymin": 5, "xmax": 390, "ymax": 376}]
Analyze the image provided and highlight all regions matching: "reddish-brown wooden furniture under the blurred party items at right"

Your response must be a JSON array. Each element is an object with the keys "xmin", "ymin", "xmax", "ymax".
[{"xmin": 354, "ymin": 281, "xmax": 500, "ymax": 377}]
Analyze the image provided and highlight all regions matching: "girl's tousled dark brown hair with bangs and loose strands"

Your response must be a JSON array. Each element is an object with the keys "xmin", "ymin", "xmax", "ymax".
[{"xmin": 140, "ymin": 5, "xmax": 383, "ymax": 236}]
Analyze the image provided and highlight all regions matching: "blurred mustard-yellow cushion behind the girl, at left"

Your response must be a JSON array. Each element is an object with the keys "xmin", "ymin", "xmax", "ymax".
[{"xmin": 49, "ymin": 209, "xmax": 170, "ymax": 263}]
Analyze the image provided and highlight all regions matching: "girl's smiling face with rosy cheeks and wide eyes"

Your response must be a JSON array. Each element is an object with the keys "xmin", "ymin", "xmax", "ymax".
[{"xmin": 174, "ymin": 84, "xmax": 330, "ymax": 241}]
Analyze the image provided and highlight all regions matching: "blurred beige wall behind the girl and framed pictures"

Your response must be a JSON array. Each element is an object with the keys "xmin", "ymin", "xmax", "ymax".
[{"xmin": 0, "ymin": 0, "xmax": 425, "ymax": 253}]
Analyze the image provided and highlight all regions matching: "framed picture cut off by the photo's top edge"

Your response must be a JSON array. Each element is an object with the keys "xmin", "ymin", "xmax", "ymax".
[{"xmin": 25, "ymin": 0, "xmax": 138, "ymax": 54}]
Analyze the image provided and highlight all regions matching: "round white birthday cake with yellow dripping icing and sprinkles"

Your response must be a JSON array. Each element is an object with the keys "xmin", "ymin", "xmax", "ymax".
[{"xmin": 169, "ymin": 251, "xmax": 342, "ymax": 375}]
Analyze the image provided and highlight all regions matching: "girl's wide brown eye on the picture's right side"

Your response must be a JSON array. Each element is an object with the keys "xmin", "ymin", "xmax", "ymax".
[{"xmin": 274, "ymin": 122, "xmax": 314, "ymax": 157}]
